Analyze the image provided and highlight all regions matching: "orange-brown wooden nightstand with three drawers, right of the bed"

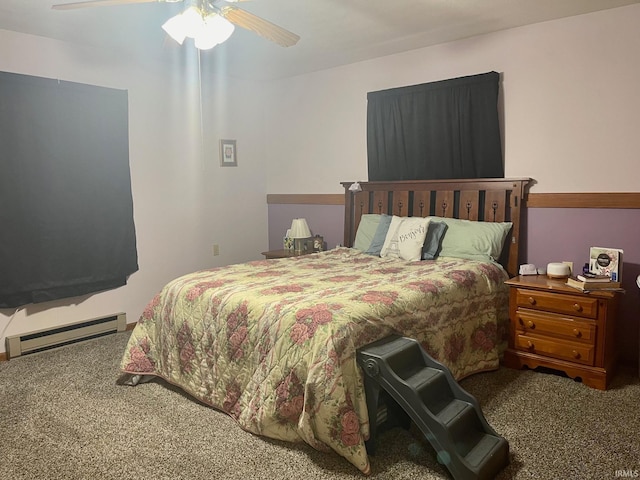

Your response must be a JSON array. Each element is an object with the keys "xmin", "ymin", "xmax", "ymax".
[{"xmin": 504, "ymin": 275, "xmax": 618, "ymax": 390}]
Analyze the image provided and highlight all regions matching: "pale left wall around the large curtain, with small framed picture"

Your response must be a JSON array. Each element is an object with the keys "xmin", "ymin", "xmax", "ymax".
[{"xmin": 0, "ymin": 30, "xmax": 268, "ymax": 354}]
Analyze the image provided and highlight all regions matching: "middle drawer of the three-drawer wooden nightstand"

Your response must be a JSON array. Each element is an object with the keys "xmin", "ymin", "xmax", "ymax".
[{"xmin": 517, "ymin": 309, "xmax": 597, "ymax": 345}]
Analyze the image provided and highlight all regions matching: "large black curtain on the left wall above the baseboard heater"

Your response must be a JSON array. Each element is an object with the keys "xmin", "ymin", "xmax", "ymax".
[{"xmin": 0, "ymin": 72, "xmax": 138, "ymax": 308}]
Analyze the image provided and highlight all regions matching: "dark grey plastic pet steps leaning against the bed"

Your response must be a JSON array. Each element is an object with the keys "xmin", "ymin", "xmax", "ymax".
[{"xmin": 357, "ymin": 335, "xmax": 509, "ymax": 480}]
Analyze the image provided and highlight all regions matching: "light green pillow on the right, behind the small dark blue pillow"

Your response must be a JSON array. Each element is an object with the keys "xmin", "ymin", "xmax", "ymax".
[{"xmin": 430, "ymin": 217, "xmax": 512, "ymax": 262}]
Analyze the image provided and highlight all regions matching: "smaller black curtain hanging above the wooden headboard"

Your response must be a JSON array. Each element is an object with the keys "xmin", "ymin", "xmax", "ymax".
[{"xmin": 367, "ymin": 72, "xmax": 504, "ymax": 180}]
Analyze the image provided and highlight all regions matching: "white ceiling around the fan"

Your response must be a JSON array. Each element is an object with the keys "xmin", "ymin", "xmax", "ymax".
[{"xmin": 0, "ymin": 0, "xmax": 640, "ymax": 79}]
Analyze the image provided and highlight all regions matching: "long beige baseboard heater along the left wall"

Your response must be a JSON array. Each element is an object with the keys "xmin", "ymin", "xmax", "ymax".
[{"xmin": 6, "ymin": 313, "xmax": 127, "ymax": 360}]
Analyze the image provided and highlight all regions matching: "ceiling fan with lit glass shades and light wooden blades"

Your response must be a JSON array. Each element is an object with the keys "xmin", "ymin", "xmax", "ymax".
[{"xmin": 52, "ymin": 0, "xmax": 300, "ymax": 50}]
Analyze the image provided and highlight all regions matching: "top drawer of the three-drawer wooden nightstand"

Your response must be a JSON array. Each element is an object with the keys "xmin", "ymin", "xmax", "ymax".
[{"xmin": 516, "ymin": 288, "xmax": 598, "ymax": 318}]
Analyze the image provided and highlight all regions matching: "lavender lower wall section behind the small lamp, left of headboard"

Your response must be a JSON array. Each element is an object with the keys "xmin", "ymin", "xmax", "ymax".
[{"xmin": 269, "ymin": 205, "xmax": 344, "ymax": 250}]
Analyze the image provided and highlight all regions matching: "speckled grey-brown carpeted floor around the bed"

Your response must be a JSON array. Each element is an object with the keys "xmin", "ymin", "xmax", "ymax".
[{"xmin": 0, "ymin": 333, "xmax": 640, "ymax": 480}]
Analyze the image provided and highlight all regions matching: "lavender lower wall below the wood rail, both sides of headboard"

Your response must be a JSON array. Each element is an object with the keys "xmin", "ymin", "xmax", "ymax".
[{"xmin": 269, "ymin": 205, "xmax": 640, "ymax": 366}]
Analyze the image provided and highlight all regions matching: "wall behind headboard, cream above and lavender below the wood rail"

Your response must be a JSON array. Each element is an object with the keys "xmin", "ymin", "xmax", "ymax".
[{"xmin": 260, "ymin": 5, "xmax": 640, "ymax": 365}]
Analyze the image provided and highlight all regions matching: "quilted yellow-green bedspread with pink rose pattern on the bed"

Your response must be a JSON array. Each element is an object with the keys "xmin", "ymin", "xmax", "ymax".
[{"xmin": 121, "ymin": 248, "xmax": 508, "ymax": 473}]
